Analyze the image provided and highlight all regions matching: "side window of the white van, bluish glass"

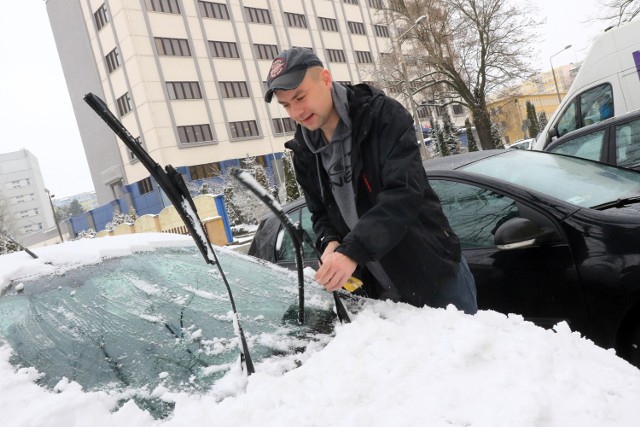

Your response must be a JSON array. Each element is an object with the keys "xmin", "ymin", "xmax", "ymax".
[{"xmin": 556, "ymin": 83, "xmax": 614, "ymax": 136}]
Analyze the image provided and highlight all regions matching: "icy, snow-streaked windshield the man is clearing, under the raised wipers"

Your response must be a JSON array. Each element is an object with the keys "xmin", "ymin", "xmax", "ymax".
[{"xmin": 0, "ymin": 247, "xmax": 334, "ymax": 415}]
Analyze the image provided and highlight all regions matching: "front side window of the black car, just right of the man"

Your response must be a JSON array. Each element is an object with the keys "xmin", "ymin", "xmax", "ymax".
[{"xmin": 429, "ymin": 179, "xmax": 520, "ymax": 249}]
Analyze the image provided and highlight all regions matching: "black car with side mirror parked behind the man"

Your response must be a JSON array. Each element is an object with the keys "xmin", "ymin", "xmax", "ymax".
[{"xmin": 249, "ymin": 150, "xmax": 640, "ymax": 366}]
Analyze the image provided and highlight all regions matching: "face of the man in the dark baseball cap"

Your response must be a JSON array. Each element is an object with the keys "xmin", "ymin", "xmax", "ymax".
[{"xmin": 274, "ymin": 67, "xmax": 335, "ymax": 131}]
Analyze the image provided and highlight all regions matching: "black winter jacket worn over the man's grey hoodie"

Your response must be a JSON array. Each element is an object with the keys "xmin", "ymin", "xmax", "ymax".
[{"xmin": 285, "ymin": 84, "xmax": 460, "ymax": 306}]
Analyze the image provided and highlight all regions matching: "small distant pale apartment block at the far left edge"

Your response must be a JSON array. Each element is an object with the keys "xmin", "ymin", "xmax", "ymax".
[{"xmin": 0, "ymin": 149, "xmax": 55, "ymax": 237}]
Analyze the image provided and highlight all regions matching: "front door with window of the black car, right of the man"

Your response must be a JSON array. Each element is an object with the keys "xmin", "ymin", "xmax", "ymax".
[{"xmin": 429, "ymin": 177, "xmax": 586, "ymax": 329}]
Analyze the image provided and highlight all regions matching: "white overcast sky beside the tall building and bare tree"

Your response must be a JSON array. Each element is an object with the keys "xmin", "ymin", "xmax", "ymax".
[{"xmin": 0, "ymin": 0, "xmax": 604, "ymax": 201}]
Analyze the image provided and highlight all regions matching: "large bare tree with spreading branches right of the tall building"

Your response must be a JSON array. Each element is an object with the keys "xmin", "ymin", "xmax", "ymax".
[{"xmin": 381, "ymin": 0, "xmax": 540, "ymax": 149}]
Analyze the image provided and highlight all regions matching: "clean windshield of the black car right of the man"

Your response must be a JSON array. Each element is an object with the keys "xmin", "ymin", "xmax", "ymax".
[{"xmin": 461, "ymin": 150, "xmax": 640, "ymax": 207}]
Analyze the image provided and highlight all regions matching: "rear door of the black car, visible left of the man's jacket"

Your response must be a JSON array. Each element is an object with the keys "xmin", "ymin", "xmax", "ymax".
[{"xmin": 275, "ymin": 205, "xmax": 318, "ymax": 270}]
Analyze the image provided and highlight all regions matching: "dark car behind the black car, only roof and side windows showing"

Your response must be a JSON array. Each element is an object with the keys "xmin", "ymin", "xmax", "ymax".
[{"xmin": 544, "ymin": 110, "xmax": 640, "ymax": 169}]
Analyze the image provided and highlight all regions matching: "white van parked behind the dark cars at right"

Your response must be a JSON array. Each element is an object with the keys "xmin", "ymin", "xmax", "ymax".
[{"xmin": 533, "ymin": 19, "xmax": 640, "ymax": 150}]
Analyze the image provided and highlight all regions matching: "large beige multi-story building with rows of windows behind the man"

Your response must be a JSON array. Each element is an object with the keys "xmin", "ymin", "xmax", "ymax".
[{"xmin": 46, "ymin": 0, "xmax": 412, "ymax": 214}]
